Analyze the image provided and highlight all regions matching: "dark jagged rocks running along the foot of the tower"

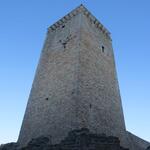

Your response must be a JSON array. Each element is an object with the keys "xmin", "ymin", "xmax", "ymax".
[{"xmin": 0, "ymin": 129, "xmax": 150, "ymax": 150}]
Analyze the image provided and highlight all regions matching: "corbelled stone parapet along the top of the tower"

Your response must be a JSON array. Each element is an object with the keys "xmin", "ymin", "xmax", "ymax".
[{"xmin": 48, "ymin": 4, "xmax": 111, "ymax": 39}]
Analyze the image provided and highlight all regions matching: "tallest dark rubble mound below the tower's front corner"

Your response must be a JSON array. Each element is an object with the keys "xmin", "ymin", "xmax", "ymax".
[{"xmin": 56, "ymin": 129, "xmax": 127, "ymax": 150}]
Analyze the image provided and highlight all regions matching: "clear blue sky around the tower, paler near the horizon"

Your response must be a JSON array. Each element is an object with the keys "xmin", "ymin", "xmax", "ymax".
[{"xmin": 0, "ymin": 0, "xmax": 150, "ymax": 143}]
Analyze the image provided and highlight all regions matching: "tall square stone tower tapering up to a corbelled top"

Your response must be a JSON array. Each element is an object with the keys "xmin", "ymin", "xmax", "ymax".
[{"xmin": 18, "ymin": 5, "xmax": 149, "ymax": 149}]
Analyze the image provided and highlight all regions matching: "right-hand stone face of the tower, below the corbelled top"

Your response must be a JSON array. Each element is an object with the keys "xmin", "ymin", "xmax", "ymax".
[{"xmin": 78, "ymin": 11, "xmax": 125, "ymax": 142}]
